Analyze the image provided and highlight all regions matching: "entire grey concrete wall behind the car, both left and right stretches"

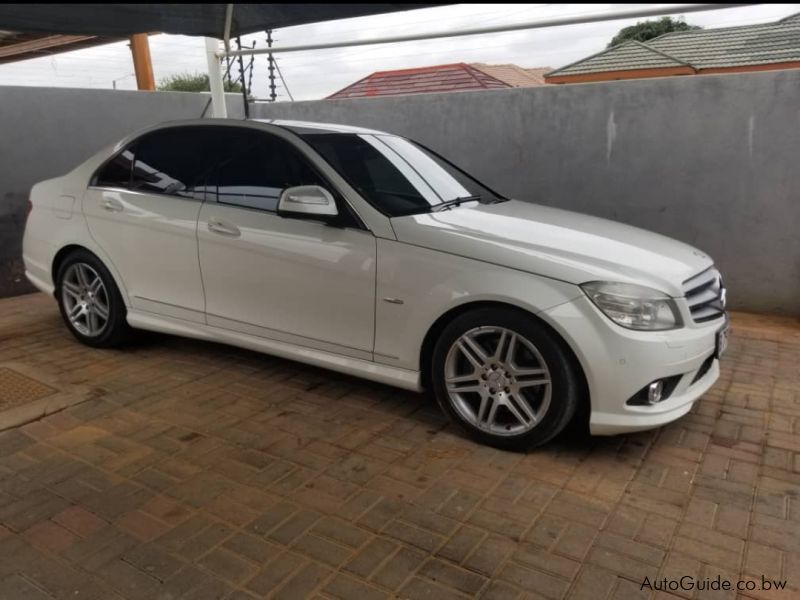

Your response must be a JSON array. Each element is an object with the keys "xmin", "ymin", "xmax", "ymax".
[{"xmin": 0, "ymin": 70, "xmax": 800, "ymax": 314}]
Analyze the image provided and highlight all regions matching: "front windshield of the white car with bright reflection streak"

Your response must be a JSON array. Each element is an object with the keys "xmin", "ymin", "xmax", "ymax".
[{"xmin": 302, "ymin": 133, "xmax": 501, "ymax": 217}]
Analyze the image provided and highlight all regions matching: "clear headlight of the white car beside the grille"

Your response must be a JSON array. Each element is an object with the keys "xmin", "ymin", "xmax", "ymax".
[{"xmin": 581, "ymin": 281, "xmax": 681, "ymax": 331}]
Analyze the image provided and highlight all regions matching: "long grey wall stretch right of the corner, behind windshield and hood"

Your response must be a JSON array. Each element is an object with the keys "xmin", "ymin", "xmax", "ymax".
[{"xmin": 254, "ymin": 70, "xmax": 800, "ymax": 315}]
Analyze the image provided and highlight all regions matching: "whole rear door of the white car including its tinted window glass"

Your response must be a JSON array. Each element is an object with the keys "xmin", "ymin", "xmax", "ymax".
[{"xmin": 83, "ymin": 126, "xmax": 214, "ymax": 322}]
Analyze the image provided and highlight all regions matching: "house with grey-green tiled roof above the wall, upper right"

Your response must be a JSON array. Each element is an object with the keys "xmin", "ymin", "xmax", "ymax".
[{"xmin": 544, "ymin": 13, "xmax": 800, "ymax": 83}]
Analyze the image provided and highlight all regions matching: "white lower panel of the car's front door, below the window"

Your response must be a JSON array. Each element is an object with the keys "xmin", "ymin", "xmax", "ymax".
[{"xmin": 197, "ymin": 202, "xmax": 375, "ymax": 360}]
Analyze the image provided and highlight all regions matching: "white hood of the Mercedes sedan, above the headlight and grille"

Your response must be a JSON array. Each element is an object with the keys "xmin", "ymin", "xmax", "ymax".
[{"xmin": 392, "ymin": 200, "xmax": 712, "ymax": 296}]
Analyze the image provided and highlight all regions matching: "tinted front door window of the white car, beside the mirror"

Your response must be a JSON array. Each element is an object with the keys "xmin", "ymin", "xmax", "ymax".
[{"xmin": 216, "ymin": 132, "xmax": 327, "ymax": 212}]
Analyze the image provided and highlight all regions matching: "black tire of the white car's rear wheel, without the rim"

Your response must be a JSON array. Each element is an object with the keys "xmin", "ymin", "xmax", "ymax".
[{"xmin": 55, "ymin": 250, "xmax": 132, "ymax": 348}]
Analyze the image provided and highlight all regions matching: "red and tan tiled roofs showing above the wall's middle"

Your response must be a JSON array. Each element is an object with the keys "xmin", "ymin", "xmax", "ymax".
[{"xmin": 328, "ymin": 63, "xmax": 550, "ymax": 99}]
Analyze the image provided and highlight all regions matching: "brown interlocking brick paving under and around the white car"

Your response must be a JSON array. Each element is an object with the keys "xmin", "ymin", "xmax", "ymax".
[{"xmin": 0, "ymin": 294, "xmax": 800, "ymax": 600}]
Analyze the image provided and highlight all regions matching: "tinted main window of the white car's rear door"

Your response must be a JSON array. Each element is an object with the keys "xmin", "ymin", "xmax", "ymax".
[{"xmin": 130, "ymin": 127, "xmax": 215, "ymax": 200}]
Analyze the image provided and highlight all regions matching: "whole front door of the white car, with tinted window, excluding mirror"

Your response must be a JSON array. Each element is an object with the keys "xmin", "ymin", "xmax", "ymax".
[{"xmin": 197, "ymin": 128, "xmax": 376, "ymax": 360}]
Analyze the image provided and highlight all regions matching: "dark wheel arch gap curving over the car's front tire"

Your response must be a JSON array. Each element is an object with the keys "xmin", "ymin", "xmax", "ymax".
[{"xmin": 419, "ymin": 300, "xmax": 591, "ymax": 419}]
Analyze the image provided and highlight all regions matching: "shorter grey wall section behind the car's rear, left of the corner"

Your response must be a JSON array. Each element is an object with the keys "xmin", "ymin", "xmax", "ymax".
[{"xmin": 0, "ymin": 87, "xmax": 242, "ymax": 297}]
